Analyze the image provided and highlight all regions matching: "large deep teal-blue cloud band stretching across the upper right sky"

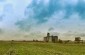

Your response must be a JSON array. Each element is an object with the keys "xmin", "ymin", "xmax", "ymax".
[{"xmin": 25, "ymin": 0, "xmax": 85, "ymax": 23}]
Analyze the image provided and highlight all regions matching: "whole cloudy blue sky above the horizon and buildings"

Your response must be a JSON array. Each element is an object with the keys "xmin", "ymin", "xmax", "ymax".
[{"xmin": 0, "ymin": 0, "xmax": 85, "ymax": 40}]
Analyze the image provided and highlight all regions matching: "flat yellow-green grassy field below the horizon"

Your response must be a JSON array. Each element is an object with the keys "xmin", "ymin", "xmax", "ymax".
[{"xmin": 0, "ymin": 42, "xmax": 85, "ymax": 55}]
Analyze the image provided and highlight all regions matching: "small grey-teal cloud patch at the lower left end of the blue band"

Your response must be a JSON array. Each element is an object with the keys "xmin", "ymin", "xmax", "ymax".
[{"xmin": 15, "ymin": 19, "xmax": 37, "ymax": 31}]
